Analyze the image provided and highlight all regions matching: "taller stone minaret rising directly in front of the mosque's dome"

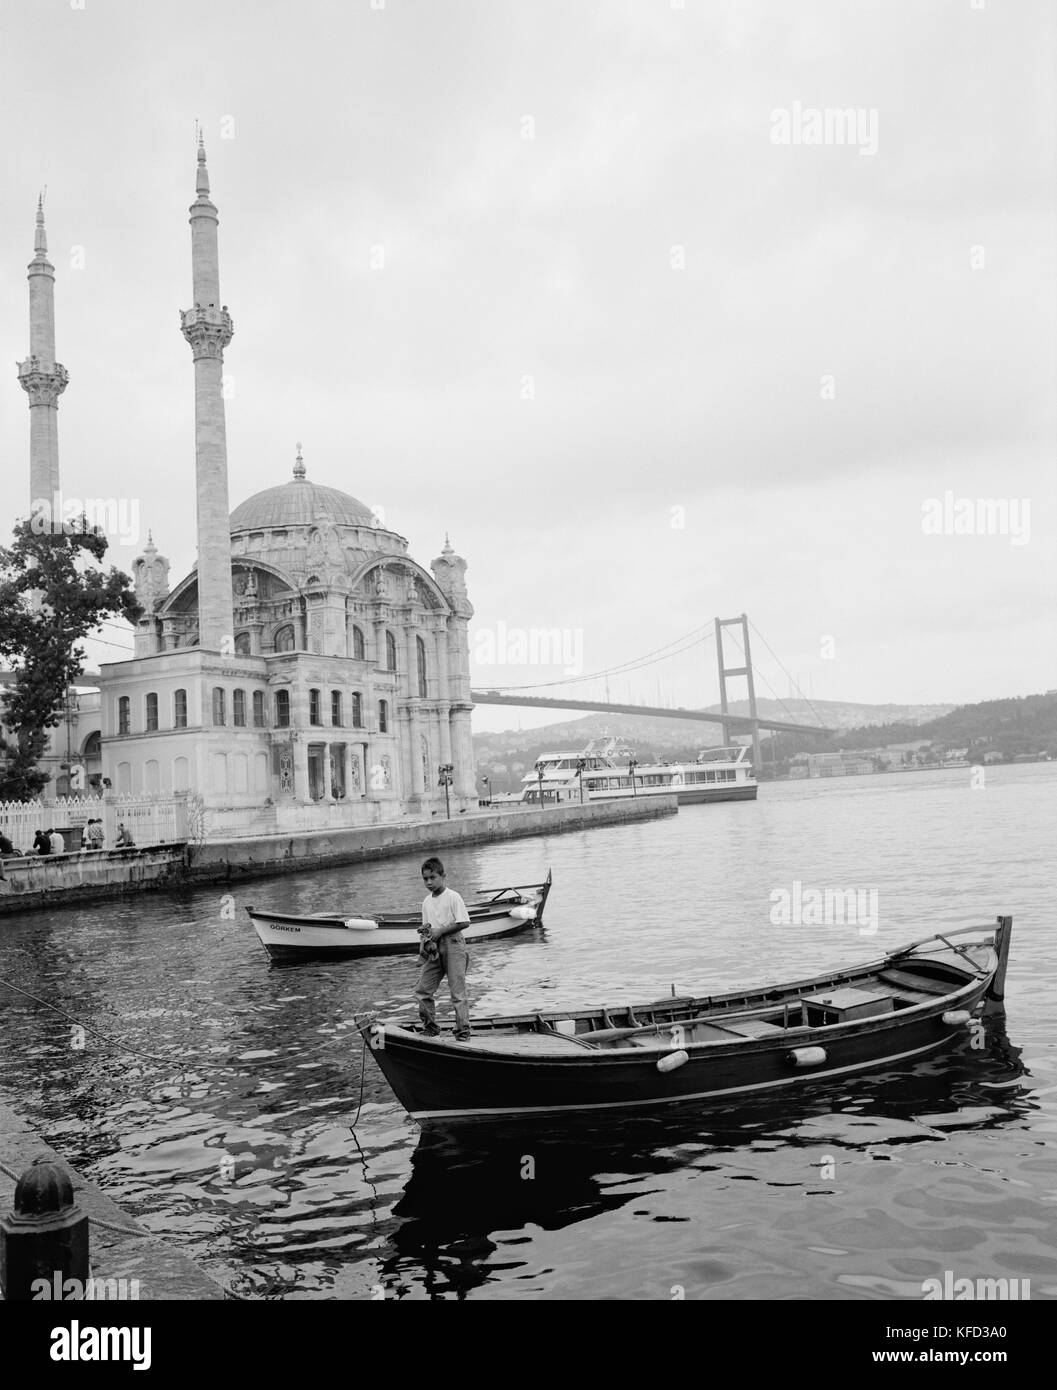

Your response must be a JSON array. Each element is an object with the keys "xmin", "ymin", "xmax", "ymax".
[{"xmin": 181, "ymin": 135, "xmax": 234, "ymax": 652}]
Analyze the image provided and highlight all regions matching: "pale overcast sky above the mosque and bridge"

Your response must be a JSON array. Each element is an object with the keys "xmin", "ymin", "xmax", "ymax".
[{"xmin": 0, "ymin": 0, "xmax": 1057, "ymax": 728}]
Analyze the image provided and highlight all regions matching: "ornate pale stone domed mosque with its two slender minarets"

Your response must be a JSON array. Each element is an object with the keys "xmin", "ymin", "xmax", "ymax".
[{"xmin": 18, "ymin": 140, "xmax": 477, "ymax": 838}]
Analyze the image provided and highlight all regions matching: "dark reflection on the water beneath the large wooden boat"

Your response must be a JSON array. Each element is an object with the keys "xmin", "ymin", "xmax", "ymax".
[{"xmin": 369, "ymin": 1016, "xmax": 1032, "ymax": 1298}]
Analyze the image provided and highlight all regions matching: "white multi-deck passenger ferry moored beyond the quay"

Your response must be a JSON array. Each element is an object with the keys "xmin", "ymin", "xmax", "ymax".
[{"xmin": 509, "ymin": 738, "xmax": 757, "ymax": 806}]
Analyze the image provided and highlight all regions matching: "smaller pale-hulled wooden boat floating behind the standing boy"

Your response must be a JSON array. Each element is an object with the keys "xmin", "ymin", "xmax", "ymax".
[{"xmin": 246, "ymin": 870, "xmax": 551, "ymax": 960}]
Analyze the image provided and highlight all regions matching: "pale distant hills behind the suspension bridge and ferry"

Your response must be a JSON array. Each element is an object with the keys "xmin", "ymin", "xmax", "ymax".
[{"xmin": 473, "ymin": 699, "xmax": 954, "ymax": 791}]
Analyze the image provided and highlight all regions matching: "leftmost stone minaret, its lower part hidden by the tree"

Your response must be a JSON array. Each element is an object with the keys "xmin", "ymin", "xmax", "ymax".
[{"xmin": 18, "ymin": 195, "xmax": 70, "ymax": 521}]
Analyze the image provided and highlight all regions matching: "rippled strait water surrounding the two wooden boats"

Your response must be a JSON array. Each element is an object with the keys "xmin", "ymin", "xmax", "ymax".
[{"xmin": 0, "ymin": 765, "xmax": 1057, "ymax": 1300}]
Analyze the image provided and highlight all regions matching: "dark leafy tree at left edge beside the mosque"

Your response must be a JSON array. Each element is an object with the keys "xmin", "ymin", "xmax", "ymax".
[{"xmin": 0, "ymin": 517, "xmax": 142, "ymax": 801}]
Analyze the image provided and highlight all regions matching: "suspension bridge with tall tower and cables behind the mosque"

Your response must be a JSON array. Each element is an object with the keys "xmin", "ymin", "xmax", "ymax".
[{"xmin": 470, "ymin": 613, "xmax": 834, "ymax": 767}]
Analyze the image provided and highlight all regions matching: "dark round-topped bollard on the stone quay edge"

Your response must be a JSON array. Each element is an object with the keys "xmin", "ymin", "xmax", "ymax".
[{"xmin": 0, "ymin": 1158, "xmax": 89, "ymax": 1302}]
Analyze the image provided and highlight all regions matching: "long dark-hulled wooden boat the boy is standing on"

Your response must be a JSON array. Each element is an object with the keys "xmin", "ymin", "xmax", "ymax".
[{"xmin": 359, "ymin": 917, "xmax": 1012, "ymax": 1122}]
